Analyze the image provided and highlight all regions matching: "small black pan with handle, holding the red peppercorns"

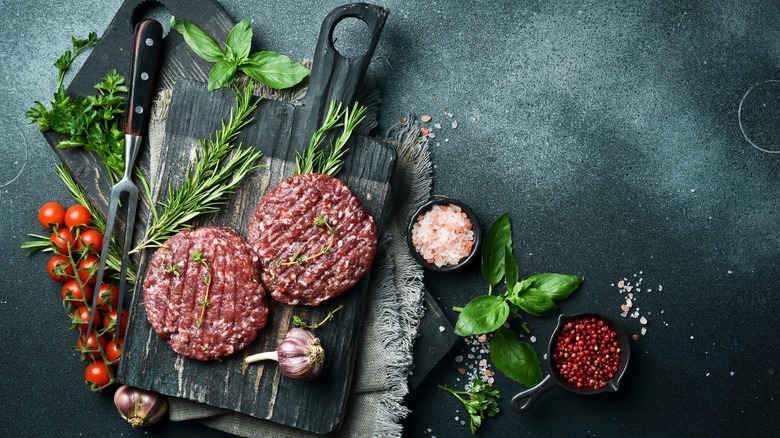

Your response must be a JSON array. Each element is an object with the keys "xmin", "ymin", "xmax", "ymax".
[{"xmin": 510, "ymin": 313, "xmax": 631, "ymax": 413}]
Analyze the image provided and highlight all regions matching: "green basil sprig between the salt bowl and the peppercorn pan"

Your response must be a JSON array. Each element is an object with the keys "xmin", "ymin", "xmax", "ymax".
[{"xmin": 455, "ymin": 213, "xmax": 583, "ymax": 386}]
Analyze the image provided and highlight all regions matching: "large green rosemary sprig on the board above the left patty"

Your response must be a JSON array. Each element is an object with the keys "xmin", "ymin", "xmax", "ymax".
[{"xmin": 131, "ymin": 82, "xmax": 263, "ymax": 253}]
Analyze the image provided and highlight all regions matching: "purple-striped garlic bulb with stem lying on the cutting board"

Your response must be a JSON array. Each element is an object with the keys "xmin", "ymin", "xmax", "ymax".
[{"xmin": 244, "ymin": 328, "xmax": 325, "ymax": 380}]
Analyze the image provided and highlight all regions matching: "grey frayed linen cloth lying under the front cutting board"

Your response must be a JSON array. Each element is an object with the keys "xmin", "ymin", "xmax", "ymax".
[{"xmin": 148, "ymin": 90, "xmax": 432, "ymax": 437}]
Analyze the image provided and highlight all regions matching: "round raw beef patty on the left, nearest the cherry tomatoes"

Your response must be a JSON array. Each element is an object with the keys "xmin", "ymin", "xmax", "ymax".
[{"xmin": 144, "ymin": 227, "xmax": 268, "ymax": 360}]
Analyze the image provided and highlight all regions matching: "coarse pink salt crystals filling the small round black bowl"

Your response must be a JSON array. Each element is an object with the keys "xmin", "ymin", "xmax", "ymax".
[{"xmin": 412, "ymin": 204, "xmax": 474, "ymax": 267}]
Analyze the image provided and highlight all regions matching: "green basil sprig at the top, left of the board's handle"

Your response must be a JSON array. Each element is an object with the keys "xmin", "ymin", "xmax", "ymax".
[{"xmin": 171, "ymin": 17, "xmax": 309, "ymax": 92}]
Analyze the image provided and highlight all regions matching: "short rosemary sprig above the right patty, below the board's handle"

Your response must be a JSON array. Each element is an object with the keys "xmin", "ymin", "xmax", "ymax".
[{"xmin": 293, "ymin": 100, "xmax": 366, "ymax": 176}]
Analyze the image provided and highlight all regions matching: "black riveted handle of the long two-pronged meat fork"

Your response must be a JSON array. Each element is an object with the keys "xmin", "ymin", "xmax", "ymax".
[{"xmin": 125, "ymin": 19, "xmax": 163, "ymax": 136}]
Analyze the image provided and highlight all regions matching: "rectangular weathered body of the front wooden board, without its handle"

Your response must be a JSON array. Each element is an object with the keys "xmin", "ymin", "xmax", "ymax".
[{"xmin": 121, "ymin": 81, "xmax": 395, "ymax": 432}]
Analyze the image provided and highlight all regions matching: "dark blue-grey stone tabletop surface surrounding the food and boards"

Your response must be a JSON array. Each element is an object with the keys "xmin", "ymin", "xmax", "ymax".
[{"xmin": 0, "ymin": 0, "xmax": 780, "ymax": 438}]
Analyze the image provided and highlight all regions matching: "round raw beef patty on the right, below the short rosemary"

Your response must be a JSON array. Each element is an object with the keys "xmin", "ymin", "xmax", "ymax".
[{"xmin": 248, "ymin": 173, "xmax": 377, "ymax": 306}]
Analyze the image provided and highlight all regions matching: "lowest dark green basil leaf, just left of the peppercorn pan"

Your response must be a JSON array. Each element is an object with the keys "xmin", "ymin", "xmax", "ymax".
[{"xmin": 490, "ymin": 327, "xmax": 543, "ymax": 387}]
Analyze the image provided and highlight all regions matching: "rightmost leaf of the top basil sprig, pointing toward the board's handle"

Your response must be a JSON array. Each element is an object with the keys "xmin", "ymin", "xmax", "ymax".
[{"xmin": 239, "ymin": 52, "xmax": 309, "ymax": 89}]
